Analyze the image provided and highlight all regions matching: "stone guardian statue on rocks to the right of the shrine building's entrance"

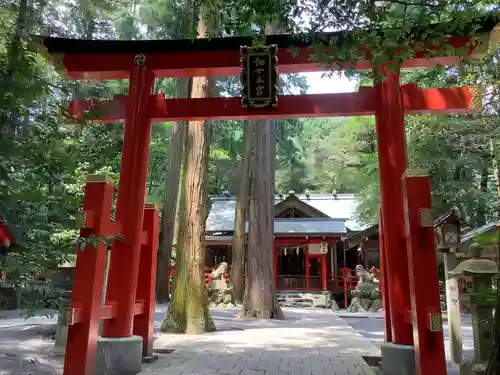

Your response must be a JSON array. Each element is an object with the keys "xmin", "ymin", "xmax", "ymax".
[{"xmin": 347, "ymin": 264, "xmax": 382, "ymax": 312}]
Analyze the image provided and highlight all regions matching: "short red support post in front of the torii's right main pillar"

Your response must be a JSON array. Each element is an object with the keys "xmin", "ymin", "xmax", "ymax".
[{"xmin": 403, "ymin": 170, "xmax": 446, "ymax": 375}]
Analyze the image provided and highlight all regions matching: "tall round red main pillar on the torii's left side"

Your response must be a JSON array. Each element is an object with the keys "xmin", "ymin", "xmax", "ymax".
[{"xmin": 103, "ymin": 55, "xmax": 154, "ymax": 337}]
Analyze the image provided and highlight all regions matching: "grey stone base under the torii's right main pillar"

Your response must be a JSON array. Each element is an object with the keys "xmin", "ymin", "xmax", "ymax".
[{"xmin": 380, "ymin": 342, "xmax": 417, "ymax": 375}]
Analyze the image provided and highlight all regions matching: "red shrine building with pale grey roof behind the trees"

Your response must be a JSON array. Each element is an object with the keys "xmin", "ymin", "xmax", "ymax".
[{"xmin": 205, "ymin": 191, "xmax": 379, "ymax": 306}]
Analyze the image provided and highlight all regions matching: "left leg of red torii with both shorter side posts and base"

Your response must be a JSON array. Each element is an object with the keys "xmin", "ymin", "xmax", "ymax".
[{"xmin": 64, "ymin": 55, "xmax": 159, "ymax": 375}]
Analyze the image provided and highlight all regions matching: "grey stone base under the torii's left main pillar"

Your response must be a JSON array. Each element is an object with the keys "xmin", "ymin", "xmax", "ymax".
[{"xmin": 94, "ymin": 336, "xmax": 142, "ymax": 375}]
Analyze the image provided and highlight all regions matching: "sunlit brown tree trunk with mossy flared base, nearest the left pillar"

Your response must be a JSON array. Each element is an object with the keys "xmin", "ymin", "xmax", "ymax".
[{"xmin": 161, "ymin": 5, "xmax": 215, "ymax": 333}]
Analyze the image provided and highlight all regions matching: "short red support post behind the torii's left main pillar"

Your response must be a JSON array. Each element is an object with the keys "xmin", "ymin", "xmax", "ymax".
[{"xmin": 134, "ymin": 204, "xmax": 160, "ymax": 357}]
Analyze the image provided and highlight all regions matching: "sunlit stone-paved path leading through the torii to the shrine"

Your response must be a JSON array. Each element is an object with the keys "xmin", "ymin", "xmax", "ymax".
[{"xmin": 141, "ymin": 309, "xmax": 380, "ymax": 375}]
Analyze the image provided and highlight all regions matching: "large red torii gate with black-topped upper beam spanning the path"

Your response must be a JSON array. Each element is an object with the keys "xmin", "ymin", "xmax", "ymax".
[{"xmin": 34, "ymin": 14, "xmax": 496, "ymax": 375}]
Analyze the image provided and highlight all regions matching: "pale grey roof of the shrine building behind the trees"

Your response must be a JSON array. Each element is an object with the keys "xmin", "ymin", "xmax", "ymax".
[{"xmin": 206, "ymin": 194, "xmax": 361, "ymax": 233}]
